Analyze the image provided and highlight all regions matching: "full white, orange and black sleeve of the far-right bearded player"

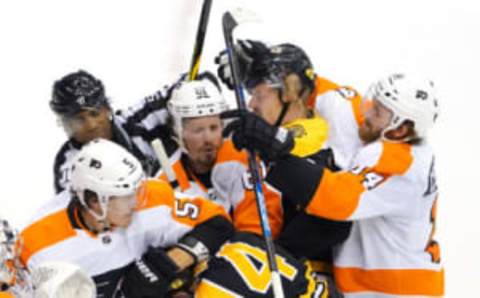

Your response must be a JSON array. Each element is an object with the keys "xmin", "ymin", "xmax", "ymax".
[{"xmin": 267, "ymin": 142, "xmax": 414, "ymax": 220}]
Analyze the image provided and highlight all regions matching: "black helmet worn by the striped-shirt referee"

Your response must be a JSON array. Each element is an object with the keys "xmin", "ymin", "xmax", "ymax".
[{"xmin": 50, "ymin": 70, "xmax": 110, "ymax": 117}]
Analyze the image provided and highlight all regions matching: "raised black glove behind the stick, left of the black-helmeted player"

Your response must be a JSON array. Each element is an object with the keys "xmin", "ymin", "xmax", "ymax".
[{"xmin": 215, "ymin": 39, "xmax": 269, "ymax": 90}]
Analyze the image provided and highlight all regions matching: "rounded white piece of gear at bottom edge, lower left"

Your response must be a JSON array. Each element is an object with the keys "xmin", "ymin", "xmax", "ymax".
[{"xmin": 31, "ymin": 262, "xmax": 96, "ymax": 298}]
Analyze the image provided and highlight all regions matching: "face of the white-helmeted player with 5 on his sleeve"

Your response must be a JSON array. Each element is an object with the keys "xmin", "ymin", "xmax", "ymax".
[{"xmin": 107, "ymin": 194, "xmax": 137, "ymax": 228}]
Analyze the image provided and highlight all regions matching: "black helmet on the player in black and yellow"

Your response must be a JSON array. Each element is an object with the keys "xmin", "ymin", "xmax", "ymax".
[{"xmin": 244, "ymin": 43, "xmax": 315, "ymax": 90}]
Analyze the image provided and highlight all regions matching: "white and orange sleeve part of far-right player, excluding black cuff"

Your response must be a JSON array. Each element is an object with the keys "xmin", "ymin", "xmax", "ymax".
[{"xmin": 306, "ymin": 142, "xmax": 414, "ymax": 220}]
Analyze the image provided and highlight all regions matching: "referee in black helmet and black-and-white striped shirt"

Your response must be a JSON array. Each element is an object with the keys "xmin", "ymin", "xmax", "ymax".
[{"xmin": 50, "ymin": 70, "xmax": 175, "ymax": 193}]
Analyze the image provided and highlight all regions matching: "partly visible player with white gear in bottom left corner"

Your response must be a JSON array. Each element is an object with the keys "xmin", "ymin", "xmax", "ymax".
[{"xmin": 0, "ymin": 219, "xmax": 95, "ymax": 298}]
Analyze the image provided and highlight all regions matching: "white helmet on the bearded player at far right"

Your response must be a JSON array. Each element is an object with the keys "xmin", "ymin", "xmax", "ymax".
[{"xmin": 365, "ymin": 74, "xmax": 439, "ymax": 139}]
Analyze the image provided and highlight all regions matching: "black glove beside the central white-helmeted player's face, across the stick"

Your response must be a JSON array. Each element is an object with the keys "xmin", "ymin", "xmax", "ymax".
[{"xmin": 221, "ymin": 110, "xmax": 295, "ymax": 161}]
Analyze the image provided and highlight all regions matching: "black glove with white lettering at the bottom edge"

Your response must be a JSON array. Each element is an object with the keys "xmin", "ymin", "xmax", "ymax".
[{"xmin": 122, "ymin": 247, "xmax": 193, "ymax": 298}]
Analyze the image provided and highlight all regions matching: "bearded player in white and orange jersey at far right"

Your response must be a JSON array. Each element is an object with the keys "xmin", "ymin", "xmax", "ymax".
[{"xmin": 227, "ymin": 74, "xmax": 444, "ymax": 297}]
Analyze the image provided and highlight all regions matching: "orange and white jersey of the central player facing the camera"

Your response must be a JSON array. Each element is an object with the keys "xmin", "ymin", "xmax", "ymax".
[{"xmin": 158, "ymin": 140, "xmax": 283, "ymax": 241}]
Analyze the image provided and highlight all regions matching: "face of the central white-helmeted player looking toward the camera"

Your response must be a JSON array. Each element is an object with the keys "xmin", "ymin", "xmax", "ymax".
[{"xmin": 183, "ymin": 115, "xmax": 223, "ymax": 171}]
